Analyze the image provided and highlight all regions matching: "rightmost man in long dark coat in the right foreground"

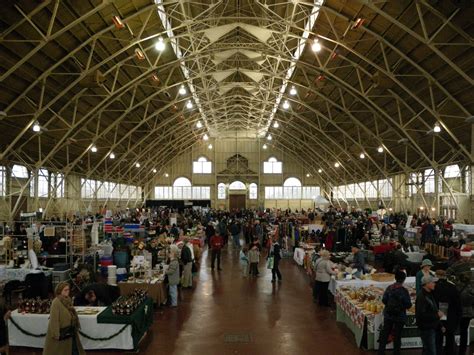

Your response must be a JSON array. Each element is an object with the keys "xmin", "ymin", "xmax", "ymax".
[{"xmin": 433, "ymin": 270, "xmax": 462, "ymax": 354}]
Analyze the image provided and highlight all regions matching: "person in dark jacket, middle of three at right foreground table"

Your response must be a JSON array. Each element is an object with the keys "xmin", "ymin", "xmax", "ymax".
[{"xmin": 415, "ymin": 275, "xmax": 444, "ymax": 355}]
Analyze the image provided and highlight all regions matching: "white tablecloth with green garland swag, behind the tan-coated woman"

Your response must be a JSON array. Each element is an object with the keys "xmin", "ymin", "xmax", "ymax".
[{"xmin": 8, "ymin": 307, "xmax": 133, "ymax": 350}]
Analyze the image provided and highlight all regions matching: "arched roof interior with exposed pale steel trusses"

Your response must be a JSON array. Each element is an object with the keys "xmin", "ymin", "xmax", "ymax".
[{"xmin": 0, "ymin": 0, "xmax": 474, "ymax": 184}]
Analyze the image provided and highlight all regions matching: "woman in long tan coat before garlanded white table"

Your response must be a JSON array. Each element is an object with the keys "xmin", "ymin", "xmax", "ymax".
[{"xmin": 43, "ymin": 282, "xmax": 85, "ymax": 355}]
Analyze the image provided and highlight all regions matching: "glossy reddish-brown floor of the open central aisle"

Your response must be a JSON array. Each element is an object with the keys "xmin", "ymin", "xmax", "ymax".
[{"xmin": 11, "ymin": 246, "xmax": 421, "ymax": 355}]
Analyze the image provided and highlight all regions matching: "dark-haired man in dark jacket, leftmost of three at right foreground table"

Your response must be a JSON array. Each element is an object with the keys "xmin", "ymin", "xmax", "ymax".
[{"xmin": 378, "ymin": 270, "xmax": 412, "ymax": 355}]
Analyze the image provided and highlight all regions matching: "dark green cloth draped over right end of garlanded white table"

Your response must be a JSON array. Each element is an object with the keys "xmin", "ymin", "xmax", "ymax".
[{"xmin": 97, "ymin": 298, "xmax": 153, "ymax": 349}]
